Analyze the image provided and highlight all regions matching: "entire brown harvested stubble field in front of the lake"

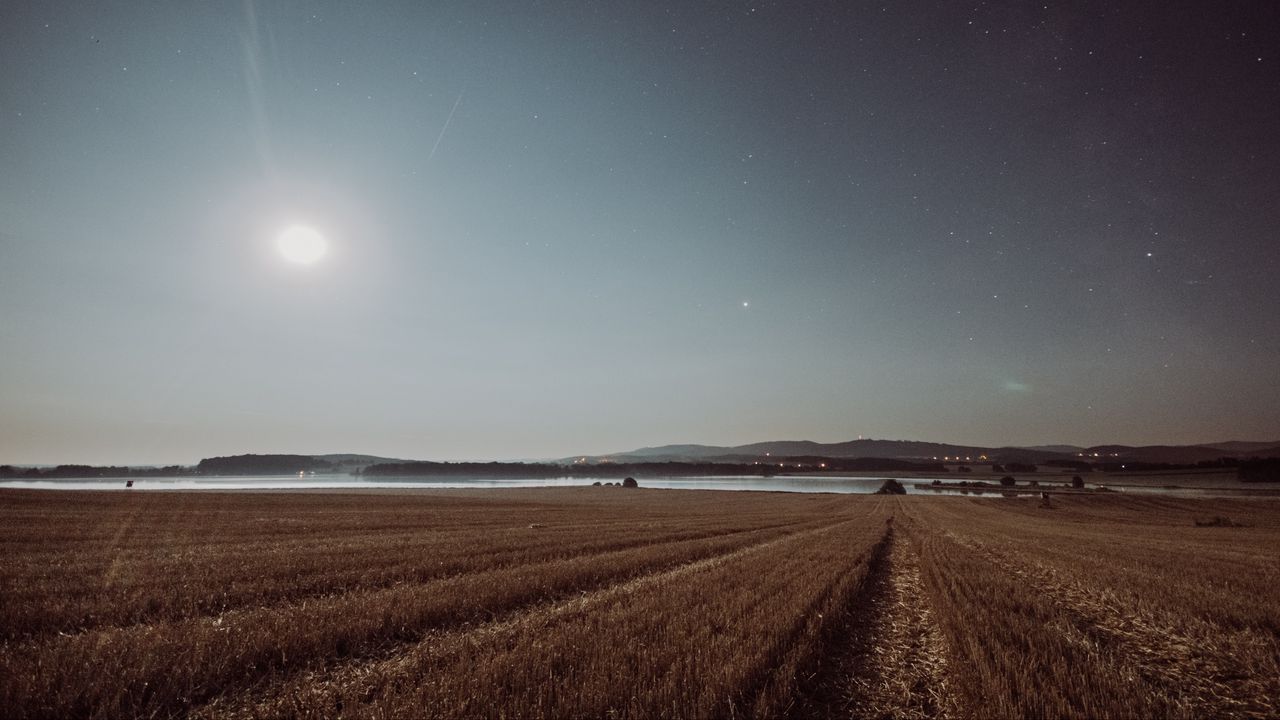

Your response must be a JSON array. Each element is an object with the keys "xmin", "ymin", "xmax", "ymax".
[{"xmin": 0, "ymin": 488, "xmax": 1280, "ymax": 717}]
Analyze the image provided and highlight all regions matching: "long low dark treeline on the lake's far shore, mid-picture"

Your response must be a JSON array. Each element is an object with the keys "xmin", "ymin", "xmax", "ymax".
[{"xmin": 364, "ymin": 457, "xmax": 947, "ymax": 478}]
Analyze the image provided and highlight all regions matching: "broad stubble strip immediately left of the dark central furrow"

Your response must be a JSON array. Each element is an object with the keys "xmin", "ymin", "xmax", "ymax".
[{"xmin": 202, "ymin": 504, "xmax": 883, "ymax": 717}]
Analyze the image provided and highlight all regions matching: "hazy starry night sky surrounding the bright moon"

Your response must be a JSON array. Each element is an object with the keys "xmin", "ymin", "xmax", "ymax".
[{"xmin": 0, "ymin": 0, "xmax": 1280, "ymax": 464}]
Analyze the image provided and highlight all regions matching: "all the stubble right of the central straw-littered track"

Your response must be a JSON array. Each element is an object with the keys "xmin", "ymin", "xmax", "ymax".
[{"xmin": 906, "ymin": 501, "xmax": 1280, "ymax": 717}]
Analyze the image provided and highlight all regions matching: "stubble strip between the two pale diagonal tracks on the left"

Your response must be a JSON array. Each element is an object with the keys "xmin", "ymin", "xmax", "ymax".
[{"xmin": 0, "ymin": 515, "xmax": 829, "ymax": 717}]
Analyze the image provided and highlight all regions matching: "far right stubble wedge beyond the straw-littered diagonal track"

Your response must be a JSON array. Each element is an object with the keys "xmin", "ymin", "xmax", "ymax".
[{"xmin": 919, "ymin": 497, "xmax": 1280, "ymax": 632}]
